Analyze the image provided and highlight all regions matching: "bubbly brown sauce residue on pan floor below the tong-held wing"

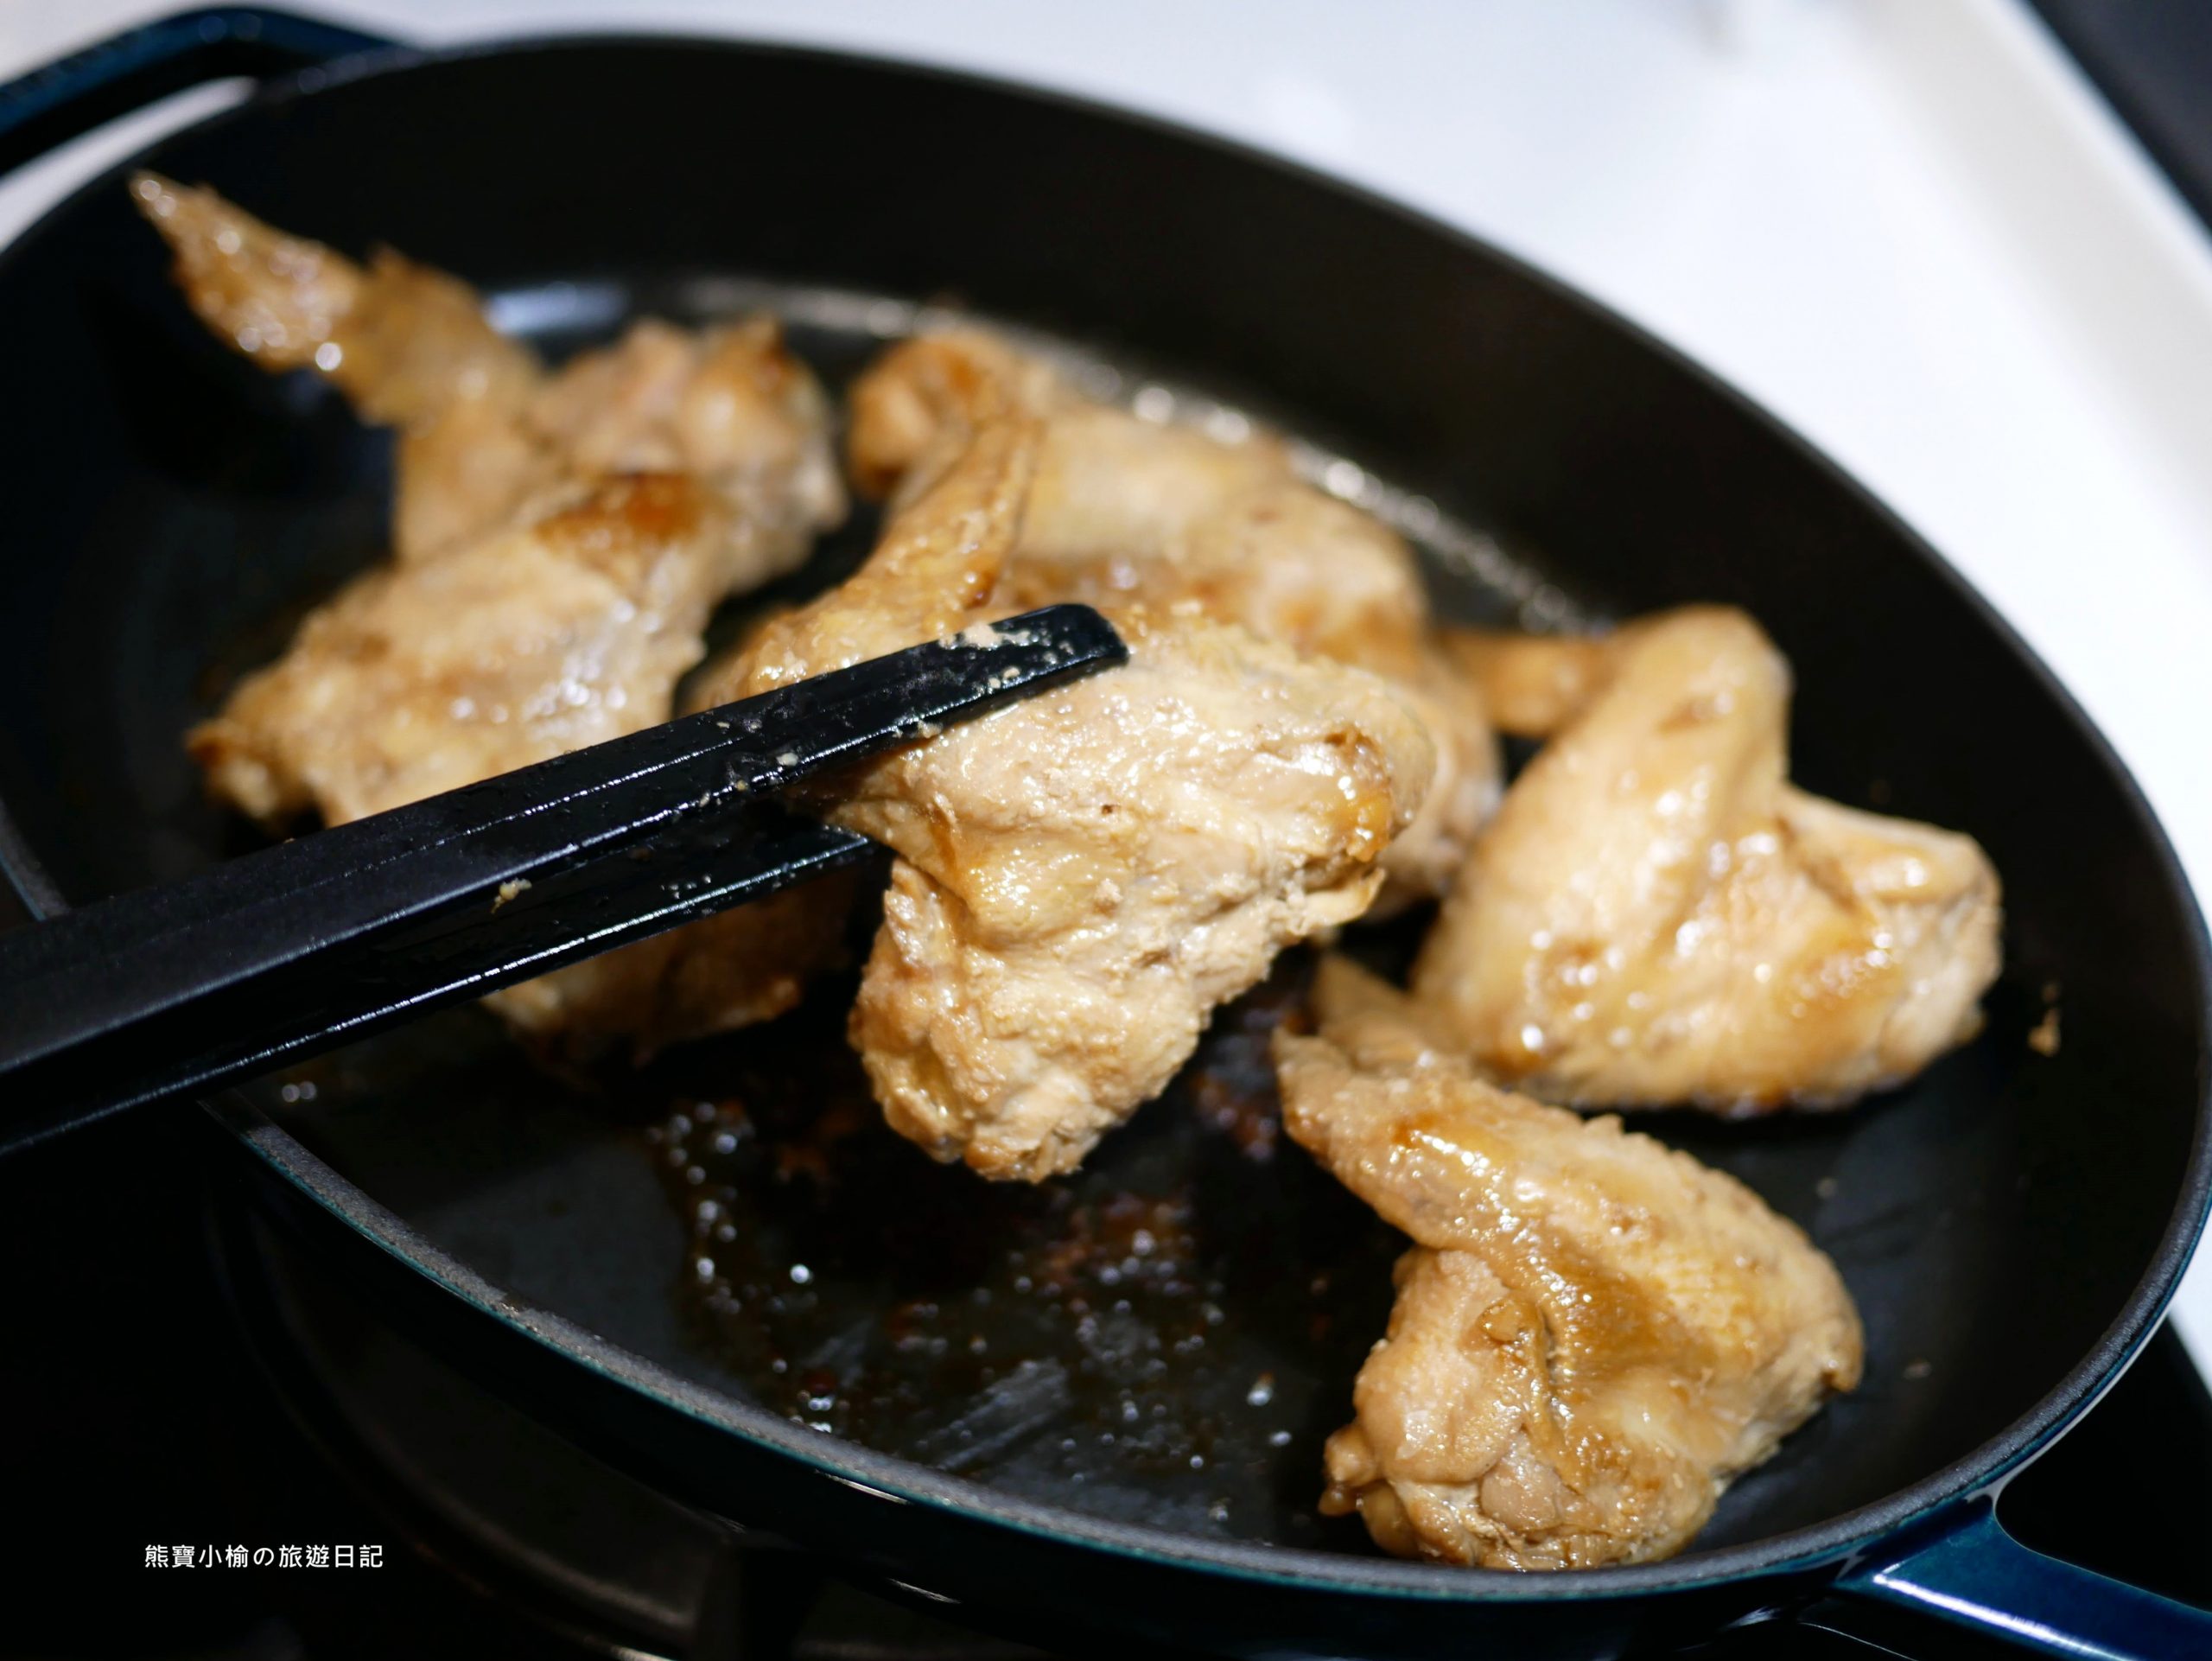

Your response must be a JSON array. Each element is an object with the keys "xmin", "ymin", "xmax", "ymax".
[{"xmin": 644, "ymin": 953, "xmax": 1402, "ymax": 1539}]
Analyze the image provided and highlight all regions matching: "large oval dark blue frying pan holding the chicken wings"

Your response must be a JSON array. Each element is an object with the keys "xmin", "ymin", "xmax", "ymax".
[{"xmin": 0, "ymin": 11, "xmax": 2212, "ymax": 1657}]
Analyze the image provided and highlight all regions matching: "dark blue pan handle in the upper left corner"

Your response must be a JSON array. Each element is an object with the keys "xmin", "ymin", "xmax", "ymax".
[{"xmin": 0, "ymin": 7, "xmax": 396, "ymax": 175}]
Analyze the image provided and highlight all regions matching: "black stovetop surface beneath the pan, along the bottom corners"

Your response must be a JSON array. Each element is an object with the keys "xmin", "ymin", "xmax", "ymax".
[{"xmin": 0, "ymin": 1092, "xmax": 2212, "ymax": 1661}]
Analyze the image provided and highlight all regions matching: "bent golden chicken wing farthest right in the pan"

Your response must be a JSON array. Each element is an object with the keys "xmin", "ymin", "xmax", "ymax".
[{"xmin": 1414, "ymin": 606, "xmax": 2002, "ymax": 1115}]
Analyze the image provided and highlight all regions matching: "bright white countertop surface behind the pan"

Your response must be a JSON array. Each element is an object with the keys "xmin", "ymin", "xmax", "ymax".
[{"xmin": 0, "ymin": 0, "xmax": 2212, "ymax": 1365}]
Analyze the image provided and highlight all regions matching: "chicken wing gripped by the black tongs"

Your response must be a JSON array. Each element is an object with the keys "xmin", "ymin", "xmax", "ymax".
[{"xmin": 715, "ymin": 343, "xmax": 1435, "ymax": 1181}]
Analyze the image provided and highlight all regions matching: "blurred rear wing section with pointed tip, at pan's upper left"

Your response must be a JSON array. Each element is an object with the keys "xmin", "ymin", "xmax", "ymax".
[{"xmin": 130, "ymin": 173, "xmax": 845, "ymax": 566}]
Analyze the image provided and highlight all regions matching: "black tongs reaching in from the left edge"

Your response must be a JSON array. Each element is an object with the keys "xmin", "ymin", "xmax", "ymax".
[{"xmin": 0, "ymin": 606, "xmax": 1126, "ymax": 1148}]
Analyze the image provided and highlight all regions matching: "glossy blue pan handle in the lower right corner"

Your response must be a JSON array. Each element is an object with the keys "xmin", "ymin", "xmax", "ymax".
[{"xmin": 1834, "ymin": 1498, "xmax": 2212, "ymax": 1661}]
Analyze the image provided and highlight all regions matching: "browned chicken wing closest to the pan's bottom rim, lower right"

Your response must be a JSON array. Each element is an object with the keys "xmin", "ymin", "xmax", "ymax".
[{"xmin": 1276, "ymin": 958, "xmax": 1863, "ymax": 1570}]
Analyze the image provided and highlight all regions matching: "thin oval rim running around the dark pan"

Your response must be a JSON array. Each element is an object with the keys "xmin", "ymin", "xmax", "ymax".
[{"xmin": 0, "ymin": 31, "xmax": 2212, "ymax": 1603}]
